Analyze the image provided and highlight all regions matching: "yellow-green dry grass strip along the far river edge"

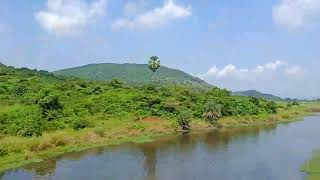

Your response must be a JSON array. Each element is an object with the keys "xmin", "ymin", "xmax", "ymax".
[{"xmin": 0, "ymin": 104, "xmax": 318, "ymax": 172}]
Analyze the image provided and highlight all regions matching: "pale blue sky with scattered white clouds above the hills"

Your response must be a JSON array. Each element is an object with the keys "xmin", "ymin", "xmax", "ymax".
[{"xmin": 0, "ymin": 0, "xmax": 320, "ymax": 98}]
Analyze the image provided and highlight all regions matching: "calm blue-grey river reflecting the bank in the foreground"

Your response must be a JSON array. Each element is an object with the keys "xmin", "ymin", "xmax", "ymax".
[{"xmin": 0, "ymin": 116, "xmax": 320, "ymax": 180}]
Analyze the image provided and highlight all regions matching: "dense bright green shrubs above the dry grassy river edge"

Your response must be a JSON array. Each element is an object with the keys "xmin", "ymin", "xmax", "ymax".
[{"xmin": 0, "ymin": 62, "xmax": 276, "ymax": 136}]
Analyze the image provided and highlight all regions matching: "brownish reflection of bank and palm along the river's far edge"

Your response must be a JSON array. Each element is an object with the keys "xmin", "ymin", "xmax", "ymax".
[{"xmin": 0, "ymin": 125, "xmax": 276, "ymax": 180}]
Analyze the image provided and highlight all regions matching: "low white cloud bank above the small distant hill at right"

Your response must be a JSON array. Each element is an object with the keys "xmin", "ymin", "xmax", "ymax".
[{"xmin": 198, "ymin": 60, "xmax": 306, "ymax": 97}]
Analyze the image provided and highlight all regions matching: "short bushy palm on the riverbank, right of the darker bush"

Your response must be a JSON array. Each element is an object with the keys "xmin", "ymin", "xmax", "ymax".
[{"xmin": 203, "ymin": 102, "xmax": 222, "ymax": 124}]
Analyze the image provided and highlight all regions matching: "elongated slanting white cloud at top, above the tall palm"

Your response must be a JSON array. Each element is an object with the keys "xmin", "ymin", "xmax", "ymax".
[{"xmin": 112, "ymin": 0, "xmax": 191, "ymax": 29}]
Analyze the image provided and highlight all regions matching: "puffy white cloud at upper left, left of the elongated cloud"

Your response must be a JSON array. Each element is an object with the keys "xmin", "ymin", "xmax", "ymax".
[{"xmin": 35, "ymin": 0, "xmax": 106, "ymax": 36}]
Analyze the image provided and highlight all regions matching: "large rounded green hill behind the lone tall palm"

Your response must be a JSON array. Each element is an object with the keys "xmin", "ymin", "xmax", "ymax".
[{"xmin": 54, "ymin": 63, "xmax": 210, "ymax": 87}]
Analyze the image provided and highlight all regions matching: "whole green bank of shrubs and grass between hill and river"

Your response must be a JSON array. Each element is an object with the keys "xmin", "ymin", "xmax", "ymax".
[{"xmin": 0, "ymin": 64, "xmax": 310, "ymax": 172}]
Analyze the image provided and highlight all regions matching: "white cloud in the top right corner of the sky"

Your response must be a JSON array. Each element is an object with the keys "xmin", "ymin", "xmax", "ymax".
[{"xmin": 273, "ymin": 0, "xmax": 320, "ymax": 29}]
